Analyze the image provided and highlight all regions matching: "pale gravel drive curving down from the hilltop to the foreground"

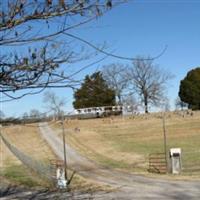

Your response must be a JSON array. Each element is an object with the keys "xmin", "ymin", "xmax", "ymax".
[{"xmin": 39, "ymin": 123, "xmax": 200, "ymax": 200}]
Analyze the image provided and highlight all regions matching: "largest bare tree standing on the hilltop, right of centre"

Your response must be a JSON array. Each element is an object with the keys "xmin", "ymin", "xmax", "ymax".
[{"xmin": 127, "ymin": 57, "xmax": 173, "ymax": 113}]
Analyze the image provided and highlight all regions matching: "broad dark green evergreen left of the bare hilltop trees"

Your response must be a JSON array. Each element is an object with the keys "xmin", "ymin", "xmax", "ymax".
[{"xmin": 73, "ymin": 72, "xmax": 115, "ymax": 108}]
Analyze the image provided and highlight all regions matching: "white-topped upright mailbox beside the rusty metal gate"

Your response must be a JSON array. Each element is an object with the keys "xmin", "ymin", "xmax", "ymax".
[{"xmin": 170, "ymin": 148, "xmax": 181, "ymax": 174}]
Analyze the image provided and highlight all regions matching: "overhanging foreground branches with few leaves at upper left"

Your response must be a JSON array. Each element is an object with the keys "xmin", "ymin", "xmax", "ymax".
[{"xmin": 0, "ymin": 0, "xmax": 127, "ymax": 101}]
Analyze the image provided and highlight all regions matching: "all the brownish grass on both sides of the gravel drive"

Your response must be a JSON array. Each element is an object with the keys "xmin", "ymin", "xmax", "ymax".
[{"xmin": 0, "ymin": 112, "xmax": 200, "ymax": 190}]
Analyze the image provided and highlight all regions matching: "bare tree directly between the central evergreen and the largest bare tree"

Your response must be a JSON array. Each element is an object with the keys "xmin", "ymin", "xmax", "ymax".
[{"xmin": 102, "ymin": 63, "xmax": 128, "ymax": 105}]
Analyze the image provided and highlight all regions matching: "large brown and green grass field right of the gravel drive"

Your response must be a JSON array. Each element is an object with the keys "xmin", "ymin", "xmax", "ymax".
[{"xmin": 53, "ymin": 112, "xmax": 200, "ymax": 176}]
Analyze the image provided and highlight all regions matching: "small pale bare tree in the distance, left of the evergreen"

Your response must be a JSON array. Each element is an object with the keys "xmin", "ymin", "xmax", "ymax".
[{"xmin": 43, "ymin": 91, "xmax": 65, "ymax": 118}]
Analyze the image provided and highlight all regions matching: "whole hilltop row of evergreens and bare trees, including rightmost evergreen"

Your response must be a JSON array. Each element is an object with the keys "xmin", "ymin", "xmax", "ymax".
[{"xmin": 73, "ymin": 61, "xmax": 200, "ymax": 113}]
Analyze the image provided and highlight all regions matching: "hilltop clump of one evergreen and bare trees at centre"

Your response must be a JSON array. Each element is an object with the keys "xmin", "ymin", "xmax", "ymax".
[{"xmin": 73, "ymin": 57, "xmax": 173, "ymax": 113}]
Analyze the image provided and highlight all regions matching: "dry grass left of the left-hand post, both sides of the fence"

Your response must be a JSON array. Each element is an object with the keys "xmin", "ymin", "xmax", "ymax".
[{"xmin": 0, "ymin": 124, "xmax": 55, "ymax": 186}]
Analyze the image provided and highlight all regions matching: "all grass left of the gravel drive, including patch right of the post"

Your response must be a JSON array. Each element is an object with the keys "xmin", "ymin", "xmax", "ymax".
[{"xmin": 0, "ymin": 124, "xmax": 109, "ymax": 192}]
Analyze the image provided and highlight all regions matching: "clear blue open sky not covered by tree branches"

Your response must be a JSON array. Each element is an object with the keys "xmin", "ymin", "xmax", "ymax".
[{"xmin": 0, "ymin": 0, "xmax": 200, "ymax": 117}]
